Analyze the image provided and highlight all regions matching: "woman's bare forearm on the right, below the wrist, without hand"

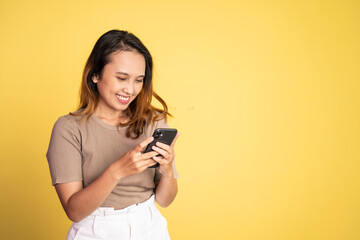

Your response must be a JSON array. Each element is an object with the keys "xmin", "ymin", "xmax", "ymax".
[{"xmin": 155, "ymin": 172, "xmax": 178, "ymax": 208}]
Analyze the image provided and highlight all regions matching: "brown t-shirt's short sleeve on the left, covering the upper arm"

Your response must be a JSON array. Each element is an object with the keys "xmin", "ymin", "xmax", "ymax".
[{"xmin": 46, "ymin": 116, "xmax": 82, "ymax": 185}]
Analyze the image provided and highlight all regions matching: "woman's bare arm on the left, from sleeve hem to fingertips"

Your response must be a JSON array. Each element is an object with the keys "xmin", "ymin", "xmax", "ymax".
[{"xmin": 55, "ymin": 137, "xmax": 158, "ymax": 222}]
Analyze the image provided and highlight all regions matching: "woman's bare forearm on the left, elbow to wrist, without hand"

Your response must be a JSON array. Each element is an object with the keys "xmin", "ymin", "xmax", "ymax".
[{"xmin": 66, "ymin": 167, "xmax": 119, "ymax": 222}]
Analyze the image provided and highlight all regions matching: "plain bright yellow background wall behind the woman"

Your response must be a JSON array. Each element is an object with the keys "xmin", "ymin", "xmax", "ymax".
[{"xmin": 0, "ymin": 0, "xmax": 360, "ymax": 240}]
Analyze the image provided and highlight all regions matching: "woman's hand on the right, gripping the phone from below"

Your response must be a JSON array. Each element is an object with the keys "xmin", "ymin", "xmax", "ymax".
[{"xmin": 152, "ymin": 133, "xmax": 180, "ymax": 176}]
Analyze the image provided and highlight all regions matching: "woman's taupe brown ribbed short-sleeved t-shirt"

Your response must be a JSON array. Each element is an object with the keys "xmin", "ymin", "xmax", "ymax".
[{"xmin": 46, "ymin": 114, "xmax": 179, "ymax": 209}]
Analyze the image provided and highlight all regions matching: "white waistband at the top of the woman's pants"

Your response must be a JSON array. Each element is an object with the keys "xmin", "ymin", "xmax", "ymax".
[{"xmin": 90, "ymin": 194, "xmax": 155, "ymax": 216}]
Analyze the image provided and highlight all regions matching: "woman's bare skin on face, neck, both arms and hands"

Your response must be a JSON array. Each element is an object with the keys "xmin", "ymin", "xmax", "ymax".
[{"xmin": 55, "ymin": 51, "xmax": 179, "ymax": 222}]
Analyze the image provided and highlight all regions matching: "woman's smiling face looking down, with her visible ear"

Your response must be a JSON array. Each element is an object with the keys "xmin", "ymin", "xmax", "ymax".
[{"xmin": 93, "ymin": 51, "xmax": 145, "ymax": 114}]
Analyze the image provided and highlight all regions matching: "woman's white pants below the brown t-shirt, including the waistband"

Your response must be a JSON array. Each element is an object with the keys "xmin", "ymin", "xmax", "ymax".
[{"xmin": 66, "ymin": 194, "xmax": 170, "ymax": 240}]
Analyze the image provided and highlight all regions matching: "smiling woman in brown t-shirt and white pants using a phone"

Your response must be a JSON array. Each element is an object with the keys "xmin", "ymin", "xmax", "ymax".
[{"xmin": 46, "ymin": 30, "xmax": 179, "ymax": 239}]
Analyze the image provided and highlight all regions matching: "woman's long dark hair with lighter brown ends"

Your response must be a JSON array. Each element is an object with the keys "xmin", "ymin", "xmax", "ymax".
[{"xmin": 70, "ymin": 29, "xmax": 171, "ymax": 138}]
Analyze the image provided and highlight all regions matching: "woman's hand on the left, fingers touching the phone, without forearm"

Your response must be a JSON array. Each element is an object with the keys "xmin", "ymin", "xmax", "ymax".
[{"xmin": 110, "ymin": 137, "xmax": 158, "ymax": 181}]
